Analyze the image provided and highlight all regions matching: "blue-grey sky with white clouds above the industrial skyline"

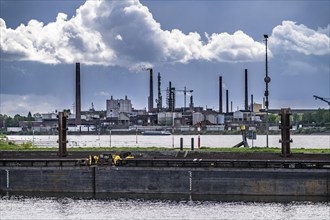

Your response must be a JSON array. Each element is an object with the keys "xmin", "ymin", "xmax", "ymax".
[{"xmin": 0, "ymin": 0, "xmax": 330, "ymax": 116}]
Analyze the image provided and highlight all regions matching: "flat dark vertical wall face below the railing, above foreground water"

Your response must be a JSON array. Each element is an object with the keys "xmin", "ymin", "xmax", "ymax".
[{"xmin": 0, "ymin": 166, "xmax": 330, "ymax": 197}]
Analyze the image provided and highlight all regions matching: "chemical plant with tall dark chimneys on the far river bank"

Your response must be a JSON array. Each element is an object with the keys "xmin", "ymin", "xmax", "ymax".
[{"xmin": 7, "ymin": 63, "xmax": 318, "ymax": 134}]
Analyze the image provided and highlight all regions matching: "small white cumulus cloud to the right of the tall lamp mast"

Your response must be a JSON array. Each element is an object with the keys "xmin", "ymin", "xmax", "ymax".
[{"xmin": 269, "ymin": 21, "xmax": 330, "ymax": 55}]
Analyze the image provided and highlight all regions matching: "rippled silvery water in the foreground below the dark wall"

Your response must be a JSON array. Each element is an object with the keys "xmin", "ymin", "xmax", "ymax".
[{"xmin": 0, "ymin": 196, "xmax": 330, "ymax": 220}]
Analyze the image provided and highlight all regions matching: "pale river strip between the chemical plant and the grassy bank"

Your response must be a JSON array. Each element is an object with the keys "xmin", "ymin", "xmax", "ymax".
[{"xmin": 8, "ymin": 135, "xmax": 330, "ymax": 148}]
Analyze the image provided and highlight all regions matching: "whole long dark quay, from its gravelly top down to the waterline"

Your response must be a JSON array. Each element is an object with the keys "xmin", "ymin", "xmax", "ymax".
[{"xmin": 0, "ymin": 151, "xmax": 330, "ymax": 200}]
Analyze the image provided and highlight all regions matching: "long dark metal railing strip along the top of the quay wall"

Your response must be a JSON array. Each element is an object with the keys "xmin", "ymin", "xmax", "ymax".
[{"xmin": 0, "ymin": 158, "xmax": 330, "ymax": 169}]
